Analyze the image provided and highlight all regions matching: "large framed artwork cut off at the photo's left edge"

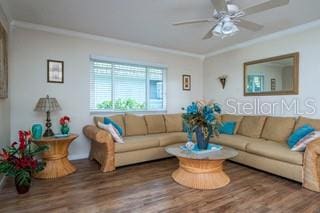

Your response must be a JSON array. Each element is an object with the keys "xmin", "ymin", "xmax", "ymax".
[{"xmin": 0, "ymin": 23, "xmax": 8, "ymax": 98}]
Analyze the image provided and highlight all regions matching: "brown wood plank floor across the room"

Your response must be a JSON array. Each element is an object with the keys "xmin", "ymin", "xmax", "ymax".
[{"xmin": 0, "ymin": 158, "xmax": 320, "ymax": 213}]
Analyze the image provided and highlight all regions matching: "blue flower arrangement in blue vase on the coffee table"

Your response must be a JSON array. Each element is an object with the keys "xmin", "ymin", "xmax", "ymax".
[{"xmin": 182, "ymin": 101, "xmax": 221, "ymax": 150}]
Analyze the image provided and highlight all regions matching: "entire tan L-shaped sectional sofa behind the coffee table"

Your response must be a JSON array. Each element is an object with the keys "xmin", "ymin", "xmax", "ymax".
[{"xmin": 83, "ymin": 114, "xmax": 320, "ymax": 192}]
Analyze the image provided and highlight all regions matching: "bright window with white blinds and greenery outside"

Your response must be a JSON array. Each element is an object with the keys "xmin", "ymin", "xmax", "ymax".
[{"xmin": 90, "ymin": 59, "xmax": 166, "ymax": 112}]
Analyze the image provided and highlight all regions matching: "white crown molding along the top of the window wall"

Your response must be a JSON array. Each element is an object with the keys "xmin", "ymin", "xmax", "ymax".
[{"xmin": 10, "ymin": 20, "xmax": 205, "ymax": 60}]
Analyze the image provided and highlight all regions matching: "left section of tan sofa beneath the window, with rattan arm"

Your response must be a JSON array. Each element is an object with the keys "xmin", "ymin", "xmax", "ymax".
[{"xmin": 83, "ymin": 114, "xmax": 187, "ymax": 172}]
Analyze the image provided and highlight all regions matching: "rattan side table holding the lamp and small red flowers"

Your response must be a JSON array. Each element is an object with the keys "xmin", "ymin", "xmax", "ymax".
[{"xmin": 32, "ymin": 134, "xmax": 78, "ymax": 179}]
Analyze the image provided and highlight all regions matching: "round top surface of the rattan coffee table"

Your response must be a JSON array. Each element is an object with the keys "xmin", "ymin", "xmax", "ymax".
[{"xmin": 165, "ymin": 143, "xmax": 238, "ymax": 160}]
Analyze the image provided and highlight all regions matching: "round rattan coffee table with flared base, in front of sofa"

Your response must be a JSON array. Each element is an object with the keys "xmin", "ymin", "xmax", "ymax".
[{"xmin": 165, "ymin": 144, "xmax": 238, "ymax": 189}]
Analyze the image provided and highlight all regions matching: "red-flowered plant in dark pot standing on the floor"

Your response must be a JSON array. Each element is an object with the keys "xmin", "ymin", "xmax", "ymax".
[{"xmin": 0, "ymin": 131, "xmax": 48, "ymax": 194}]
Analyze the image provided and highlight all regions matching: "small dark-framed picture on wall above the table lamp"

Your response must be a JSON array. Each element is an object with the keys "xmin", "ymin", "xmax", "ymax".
[{"xmin": 47, "ymin": 60, "xmax": 64, "ymax": 83}]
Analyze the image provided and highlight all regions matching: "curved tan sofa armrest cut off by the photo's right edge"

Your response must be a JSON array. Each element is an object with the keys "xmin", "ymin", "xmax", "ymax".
[{"xmin": 303, "ymin": 139, "xmax": 320, "ymax": 192}]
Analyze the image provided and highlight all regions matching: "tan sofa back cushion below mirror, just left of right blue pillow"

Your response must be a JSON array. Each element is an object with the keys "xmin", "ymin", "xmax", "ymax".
[{"xmin": 261, "ymin": 117, "xmax": 296, "ymax": 142}]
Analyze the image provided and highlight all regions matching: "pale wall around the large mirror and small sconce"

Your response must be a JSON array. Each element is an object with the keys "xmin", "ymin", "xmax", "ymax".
[{"xmin": 204, "ymin": 27, "xmax": 320, "ymax": 117}]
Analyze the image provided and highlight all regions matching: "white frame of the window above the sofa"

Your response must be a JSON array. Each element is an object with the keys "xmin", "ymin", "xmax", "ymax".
[{"xmin": 89, "ymin": 56, "xmax": 168, "ymax": 114}]
